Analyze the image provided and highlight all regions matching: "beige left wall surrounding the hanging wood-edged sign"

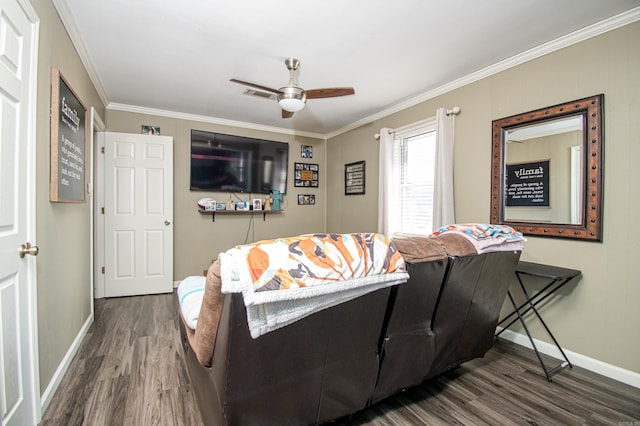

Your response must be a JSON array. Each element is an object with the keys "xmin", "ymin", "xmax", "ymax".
[{"xmin": 31, "ymin": 0, "xmax": 104, "ymax": 392}]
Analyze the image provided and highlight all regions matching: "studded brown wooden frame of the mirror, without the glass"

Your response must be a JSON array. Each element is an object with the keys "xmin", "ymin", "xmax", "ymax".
[{"xmin": 491, "ymin": 94, "xmax": 604, "ymax": 241}]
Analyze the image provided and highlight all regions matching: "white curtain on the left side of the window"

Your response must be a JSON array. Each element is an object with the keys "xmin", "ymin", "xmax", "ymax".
[{"xmin": 378, "ymin": 127, "xmax": 395, "ymax": 236}]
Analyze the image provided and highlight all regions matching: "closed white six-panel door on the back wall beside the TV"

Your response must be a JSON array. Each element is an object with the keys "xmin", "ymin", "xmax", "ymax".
[{"xmin": 104, "ymin": 132, "xmax": 173, "ymax": 297}]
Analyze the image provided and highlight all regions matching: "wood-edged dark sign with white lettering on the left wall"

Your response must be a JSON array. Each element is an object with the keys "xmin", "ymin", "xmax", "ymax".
[{"xmin": 49, "ymin": 68, "xmax": 87, "ymax": 203}]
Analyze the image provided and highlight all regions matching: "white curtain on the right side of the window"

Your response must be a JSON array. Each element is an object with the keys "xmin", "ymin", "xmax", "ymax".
[{"xmin": 432, "ymin": 108, "xmax": 455, "ymax": 231}]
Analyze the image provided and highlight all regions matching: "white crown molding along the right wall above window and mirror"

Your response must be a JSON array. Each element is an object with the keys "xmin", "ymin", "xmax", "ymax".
[{"xmin": 325, "ymin": 6, "xmax": 640, "ymax": 139}]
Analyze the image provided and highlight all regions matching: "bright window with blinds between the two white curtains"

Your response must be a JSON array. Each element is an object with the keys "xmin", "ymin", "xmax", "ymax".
[{"xmin": 383, "ymin": 121, "xmax": 436, "ymax": 235}]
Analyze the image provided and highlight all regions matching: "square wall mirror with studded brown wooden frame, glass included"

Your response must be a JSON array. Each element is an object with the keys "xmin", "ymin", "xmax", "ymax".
[{"xmin": 491, "ymin": 94, "xmax": 604, "ymax": 241}]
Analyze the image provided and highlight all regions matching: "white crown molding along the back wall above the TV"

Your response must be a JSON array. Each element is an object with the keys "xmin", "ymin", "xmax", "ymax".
[{"xmin": 107, "ymin": 103, "xmax": 325, "ymax": 140}]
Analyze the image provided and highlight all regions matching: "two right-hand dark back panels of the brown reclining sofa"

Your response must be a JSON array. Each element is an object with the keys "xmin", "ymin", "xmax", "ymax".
[{"xmin": 371, "ymin": 251, "xmax": 520, "ymax": 403}]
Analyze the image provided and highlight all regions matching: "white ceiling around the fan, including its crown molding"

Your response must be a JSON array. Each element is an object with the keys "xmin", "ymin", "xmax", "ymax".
[{"xmin": 54, "ymin": 0, "xmax": 640, "ymax": 136}]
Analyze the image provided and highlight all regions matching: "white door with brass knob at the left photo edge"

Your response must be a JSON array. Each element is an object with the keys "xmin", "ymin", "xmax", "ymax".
[{"xmin": 0, "ymin": 0, "xmax": 39, "ymax": 425}]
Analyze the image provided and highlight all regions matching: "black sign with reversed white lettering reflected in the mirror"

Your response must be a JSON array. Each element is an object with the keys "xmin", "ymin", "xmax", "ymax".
[{"xmin": 505, "ymin": 160, "xmax": 549, "ymax": 207}]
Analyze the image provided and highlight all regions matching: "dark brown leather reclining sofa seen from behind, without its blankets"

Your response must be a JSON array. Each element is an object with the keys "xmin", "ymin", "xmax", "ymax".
[{"xmin": 175, "ymin": 235, "xmax": 520, "ymax": 426}]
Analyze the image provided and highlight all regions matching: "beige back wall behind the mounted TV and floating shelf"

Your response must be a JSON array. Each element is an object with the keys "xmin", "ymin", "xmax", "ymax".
[{"xmin": 107, "ymin": 110, "xmax": 327, "ymax": 281}]
